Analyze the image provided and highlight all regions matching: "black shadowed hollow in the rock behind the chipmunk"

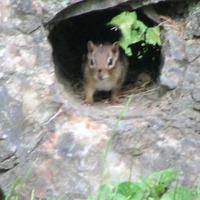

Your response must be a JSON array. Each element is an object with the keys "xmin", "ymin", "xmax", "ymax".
[{"xmin": 49, "ymin": 8, "xmax": 161, "ymax": 104}]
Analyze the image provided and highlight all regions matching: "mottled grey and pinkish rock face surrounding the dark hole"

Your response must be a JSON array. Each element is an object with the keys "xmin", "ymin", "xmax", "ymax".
[{"xmin": 0, "ymin": 0, "xmax": 200, "ymax": 199}]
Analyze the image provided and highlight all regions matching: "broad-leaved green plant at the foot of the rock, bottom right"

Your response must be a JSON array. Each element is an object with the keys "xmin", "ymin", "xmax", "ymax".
[{"xmin": 87, "ymin": 169, "xmax": 199, "ymax": 200}]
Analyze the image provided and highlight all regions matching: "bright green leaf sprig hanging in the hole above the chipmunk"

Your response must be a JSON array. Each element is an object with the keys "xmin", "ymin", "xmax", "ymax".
[{"xmin": 108, "ymin": 11, "xmax": 161, "ymax": 56}]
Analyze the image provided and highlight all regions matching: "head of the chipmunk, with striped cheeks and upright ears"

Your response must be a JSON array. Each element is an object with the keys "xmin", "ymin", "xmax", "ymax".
[{"xmin": 88, "ymin": 41, "xmax": 119, "ymax": 81}]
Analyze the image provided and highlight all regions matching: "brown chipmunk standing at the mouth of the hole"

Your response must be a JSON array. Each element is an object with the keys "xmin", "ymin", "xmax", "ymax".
[{"xmin": 83, "ymin": 41, "xmax": 128, "ymax": 105}]
